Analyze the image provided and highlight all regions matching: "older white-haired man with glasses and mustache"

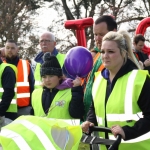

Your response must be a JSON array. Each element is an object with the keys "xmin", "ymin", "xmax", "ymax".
[{"xmin": 34, "ymin": 31, "xmax": 65, "ymax": 88}]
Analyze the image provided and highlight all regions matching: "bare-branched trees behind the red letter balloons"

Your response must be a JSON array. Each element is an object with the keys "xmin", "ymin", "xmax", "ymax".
[{"xmin": 44, "ymin": 0, "xmax": 150, "ymax": 52}]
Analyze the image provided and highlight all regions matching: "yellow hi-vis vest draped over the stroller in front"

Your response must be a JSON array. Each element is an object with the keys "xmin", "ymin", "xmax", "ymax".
[{"xmin": 0, "ymin": 116, "xmax": 82, "ymax": 150}]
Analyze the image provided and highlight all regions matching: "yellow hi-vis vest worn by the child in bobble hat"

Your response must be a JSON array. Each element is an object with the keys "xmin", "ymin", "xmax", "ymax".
[{"xmin": 32, "ymin": 88, "xmax": 72, "ymax": 119}]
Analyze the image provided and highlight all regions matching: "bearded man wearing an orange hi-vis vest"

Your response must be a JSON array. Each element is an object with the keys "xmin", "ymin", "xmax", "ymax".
[{"xmin": 5, "ymin": 39, "xmax": 34, "ymax": 116}]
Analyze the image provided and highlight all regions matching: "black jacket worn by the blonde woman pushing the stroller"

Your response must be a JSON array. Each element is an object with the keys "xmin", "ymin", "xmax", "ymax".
[{"xmin": 87, "ymin": 60, "xmax": 150, "ymax": 140}]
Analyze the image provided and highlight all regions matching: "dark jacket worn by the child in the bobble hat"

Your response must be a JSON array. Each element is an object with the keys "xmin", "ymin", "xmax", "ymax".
[{"xmin": 30, "ymin": 86, "xmax": 84, "ymax": 120}]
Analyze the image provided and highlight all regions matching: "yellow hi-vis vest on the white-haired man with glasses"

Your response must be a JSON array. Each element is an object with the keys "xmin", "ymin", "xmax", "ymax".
[{"xmin": 34, "ymin": 53, "xmax": 65, "ymax": 89}]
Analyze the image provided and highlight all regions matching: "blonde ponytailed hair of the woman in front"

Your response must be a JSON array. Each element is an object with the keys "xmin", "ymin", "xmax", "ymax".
[{"xmin": 103, "ymin": 30, "xmax": 141, "ymax": 69}]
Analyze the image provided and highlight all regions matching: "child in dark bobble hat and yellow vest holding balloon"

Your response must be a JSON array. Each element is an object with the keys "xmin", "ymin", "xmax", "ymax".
[{"xmin": 31, "ymin": 52, "xmax": 84, "ymax": 120}]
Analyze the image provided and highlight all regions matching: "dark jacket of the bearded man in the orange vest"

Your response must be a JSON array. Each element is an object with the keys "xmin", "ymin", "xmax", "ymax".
[{"xmin": 6, "ymin": 56, "xmax": 35, "ymax": 100}]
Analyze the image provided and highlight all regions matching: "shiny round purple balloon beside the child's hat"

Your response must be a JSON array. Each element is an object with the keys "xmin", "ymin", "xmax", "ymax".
[{"xmin": 64, "ymin": 46, "xmax": 93, "ymax": 77}]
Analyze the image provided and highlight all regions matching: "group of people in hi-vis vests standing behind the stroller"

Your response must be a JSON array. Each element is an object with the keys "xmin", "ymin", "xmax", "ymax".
[{"xmin": 0, "ymin": 15, "xmax": 150, "ymax": 150}]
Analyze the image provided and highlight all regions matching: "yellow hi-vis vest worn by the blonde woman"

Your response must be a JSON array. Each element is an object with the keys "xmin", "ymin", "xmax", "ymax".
[{"xmin": 92, "ymin": 70, "xmax": 150, "ymax": 150}]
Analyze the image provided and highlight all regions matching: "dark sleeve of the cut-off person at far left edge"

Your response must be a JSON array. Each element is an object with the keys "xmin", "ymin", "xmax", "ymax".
[{"xmin": 0, "ymin": 59, "xmax": 17, "ymax": 120}]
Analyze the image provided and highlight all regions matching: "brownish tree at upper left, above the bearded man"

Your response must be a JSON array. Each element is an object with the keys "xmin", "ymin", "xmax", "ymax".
[{"xmin": 0, "ymin": 0, "xmax": 42, "ymax": 58}]
